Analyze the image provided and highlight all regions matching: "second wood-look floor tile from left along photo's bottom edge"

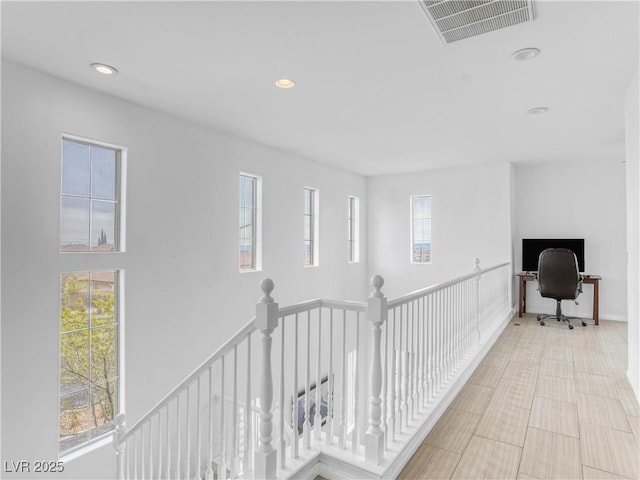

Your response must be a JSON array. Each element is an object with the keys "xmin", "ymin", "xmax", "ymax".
[{"xmin": 451, "ymin": 435, "xmax": 521, "ymax": 480}]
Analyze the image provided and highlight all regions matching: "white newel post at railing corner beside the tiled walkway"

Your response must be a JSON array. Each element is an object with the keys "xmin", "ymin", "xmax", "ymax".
[{"xmin": 364, "ymin": 275, "xmax": 387, "ymax": 465}]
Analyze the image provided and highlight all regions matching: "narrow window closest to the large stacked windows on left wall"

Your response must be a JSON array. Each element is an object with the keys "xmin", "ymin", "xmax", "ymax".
[{"xmin": 240, "ymin": 173, "xmax": 261, "ymax": 272}]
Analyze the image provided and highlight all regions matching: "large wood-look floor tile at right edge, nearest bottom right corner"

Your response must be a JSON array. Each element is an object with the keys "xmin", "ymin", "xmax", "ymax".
[{"xmin": 580, "ymin": 423, "xmax": 640, "ymax": 478}]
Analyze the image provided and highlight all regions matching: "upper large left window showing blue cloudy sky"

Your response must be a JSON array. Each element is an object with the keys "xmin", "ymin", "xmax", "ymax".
[{"xmin": 60, "ymin": 138, "xmax": 120, "ymax": 252}]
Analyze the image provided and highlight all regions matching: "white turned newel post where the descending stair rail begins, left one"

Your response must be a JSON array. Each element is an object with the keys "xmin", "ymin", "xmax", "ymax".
[{"xmin": 253, "ymin": 278, "xmax": 278, "ymax": 479}]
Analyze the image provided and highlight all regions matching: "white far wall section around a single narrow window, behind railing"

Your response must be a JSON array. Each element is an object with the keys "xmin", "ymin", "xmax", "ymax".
[{"xmin": 367, "ymin": 164, "xmax": 512, "ymax": 298}]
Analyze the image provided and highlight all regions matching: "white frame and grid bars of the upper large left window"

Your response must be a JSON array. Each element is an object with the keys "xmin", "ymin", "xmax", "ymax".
[{"xmin": 58, "ymin": 133, "xmax": 127, "ymax": 254}]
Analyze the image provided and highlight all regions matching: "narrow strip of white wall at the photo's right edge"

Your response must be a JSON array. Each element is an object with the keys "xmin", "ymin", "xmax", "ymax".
[{"xmin": 625, "ymin": 65, "xmax": 640, "ymax": 399}]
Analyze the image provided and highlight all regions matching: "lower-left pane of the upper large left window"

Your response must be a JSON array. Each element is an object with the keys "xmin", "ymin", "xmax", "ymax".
[{"xmin": 60, "ymin": 196, "xmax": 89, "ymax": 252}]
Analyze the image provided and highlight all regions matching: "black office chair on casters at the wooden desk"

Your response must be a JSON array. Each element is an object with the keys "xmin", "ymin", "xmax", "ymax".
[{"xmin": 537, "ymin": 248, "xmax": 587, "ymax": 329}]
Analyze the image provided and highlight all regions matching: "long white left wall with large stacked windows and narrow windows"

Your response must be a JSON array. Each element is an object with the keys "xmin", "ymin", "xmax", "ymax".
[{"xmin": 2, "ymin": 63, "xmax": 367, "ymax": 478}]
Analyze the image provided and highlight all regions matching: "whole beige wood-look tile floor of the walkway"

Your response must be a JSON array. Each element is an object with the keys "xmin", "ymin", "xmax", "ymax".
[{"xmin": 398, "ymin": 315, "xmax": 640, "ymax": 480}]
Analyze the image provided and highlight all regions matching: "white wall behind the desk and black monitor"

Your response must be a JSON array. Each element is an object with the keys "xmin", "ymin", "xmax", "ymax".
[{"xmin": 515, "ymin": 158, "xmax": 627, "ymax": 320}]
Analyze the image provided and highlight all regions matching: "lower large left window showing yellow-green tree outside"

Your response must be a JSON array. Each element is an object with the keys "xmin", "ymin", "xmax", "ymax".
[{"xmin": 59, "ymin": 271, "xmax": 120, "ymax": 453}]
